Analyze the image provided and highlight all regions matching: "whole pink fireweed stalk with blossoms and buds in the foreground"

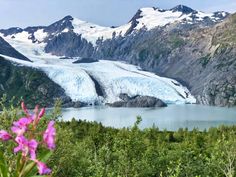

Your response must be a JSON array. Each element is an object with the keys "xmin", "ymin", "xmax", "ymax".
[{"xmin": 0, "ymin": 102, "xmax": 56, "ymax": 177}]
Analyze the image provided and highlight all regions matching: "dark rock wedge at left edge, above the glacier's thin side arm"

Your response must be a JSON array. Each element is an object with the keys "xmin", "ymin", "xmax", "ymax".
[{"xmin": 0, "ymin": 37, "xmax": 30, "ymax": 61}]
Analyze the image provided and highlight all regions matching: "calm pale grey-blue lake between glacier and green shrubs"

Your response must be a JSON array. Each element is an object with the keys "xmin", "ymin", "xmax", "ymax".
[{"xmin": 62, "ymin": 105, "xmax": 236, "ymax": 131}]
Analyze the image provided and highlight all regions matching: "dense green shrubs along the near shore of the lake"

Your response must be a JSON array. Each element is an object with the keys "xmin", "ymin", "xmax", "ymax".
[{"xmin": 0, "ymin": 99, "xmax": 236, "ymax": 177}]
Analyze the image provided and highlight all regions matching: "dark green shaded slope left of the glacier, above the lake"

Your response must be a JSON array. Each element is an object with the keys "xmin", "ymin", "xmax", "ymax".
[{"xmin": 0, "ymin": 57, "xmax": 68, "ymax": 108}]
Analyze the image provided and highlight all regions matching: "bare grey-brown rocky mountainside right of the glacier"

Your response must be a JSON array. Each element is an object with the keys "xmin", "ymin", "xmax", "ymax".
[{"xmin": 94, "ymin": 15, "xmax": 236, "ymax": 106}]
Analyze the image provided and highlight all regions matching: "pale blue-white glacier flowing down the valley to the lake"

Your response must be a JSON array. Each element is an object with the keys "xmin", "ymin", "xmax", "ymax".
[{"xmin": 0, "ymin": 31, "xmax": 196, "ymax": 104}]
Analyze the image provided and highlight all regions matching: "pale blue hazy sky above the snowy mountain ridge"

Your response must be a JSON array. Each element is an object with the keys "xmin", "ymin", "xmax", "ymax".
[{"xmin": 0, "ymin": 0, "xmax": 236, "ymax": 29}]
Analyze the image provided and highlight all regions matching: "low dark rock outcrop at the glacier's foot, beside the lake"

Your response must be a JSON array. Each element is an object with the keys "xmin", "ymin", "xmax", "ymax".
[{"xmin": 107, "ymin": 94, "xmax": 167, "ymax": 107}]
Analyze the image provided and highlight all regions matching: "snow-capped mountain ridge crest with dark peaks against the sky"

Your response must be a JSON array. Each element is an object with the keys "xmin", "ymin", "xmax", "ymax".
[{"xmin": 0, "ymin": 5, "xmax": 229, "ymax": 46}]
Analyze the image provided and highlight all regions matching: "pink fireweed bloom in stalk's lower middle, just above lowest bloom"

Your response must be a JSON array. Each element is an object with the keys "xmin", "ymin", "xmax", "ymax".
[{"xmin": 14, "ymin": 136, "xmax": 38, "ymax": 159}]
